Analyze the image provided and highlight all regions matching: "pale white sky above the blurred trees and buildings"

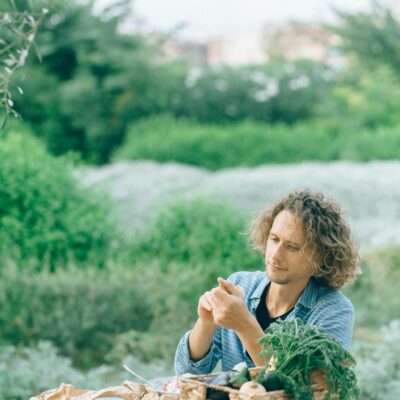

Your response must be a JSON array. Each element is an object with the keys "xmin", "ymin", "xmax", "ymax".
[{"xmin": 98, "ymin": 0, "xmax": 376, "ymax": 42}]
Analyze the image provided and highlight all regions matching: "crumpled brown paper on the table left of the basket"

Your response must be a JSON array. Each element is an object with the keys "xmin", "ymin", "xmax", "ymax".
[{"xmin": 30, "ymin": 381, "xmax": 178, "ymax": 400}]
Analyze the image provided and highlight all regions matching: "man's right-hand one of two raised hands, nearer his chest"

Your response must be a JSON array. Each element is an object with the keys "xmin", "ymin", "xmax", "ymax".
[{"xmin": 207, "ymin": 278, "xmax": 252, "ymax": 332}]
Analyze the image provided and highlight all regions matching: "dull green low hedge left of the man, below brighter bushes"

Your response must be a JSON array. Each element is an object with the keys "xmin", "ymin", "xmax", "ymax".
[{"xmin": 0, "ymin": 262, "xmax": 225, "ymax": 368}]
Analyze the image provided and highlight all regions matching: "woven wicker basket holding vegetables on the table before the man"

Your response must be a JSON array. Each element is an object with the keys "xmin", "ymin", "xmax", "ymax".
[{"xmin": 179, "ymin": 368, "xmax": 326, "ymax": 400}]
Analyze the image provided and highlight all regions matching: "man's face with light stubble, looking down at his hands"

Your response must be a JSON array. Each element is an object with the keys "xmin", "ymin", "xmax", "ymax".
[{"xmin": 265, "ymin": 210, "xmax": 313, "ymax": 287}]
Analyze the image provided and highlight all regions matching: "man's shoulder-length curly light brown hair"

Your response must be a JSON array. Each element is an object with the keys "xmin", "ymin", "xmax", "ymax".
[{"xmin": 251, "ymin": 190, "xmax": 361, "ymax": 289}]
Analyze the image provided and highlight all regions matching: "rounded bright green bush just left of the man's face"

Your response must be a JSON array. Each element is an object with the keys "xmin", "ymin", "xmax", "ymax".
[{"xmin": 132, "ymin": 198, "xmax": 262, "ymax": 285}]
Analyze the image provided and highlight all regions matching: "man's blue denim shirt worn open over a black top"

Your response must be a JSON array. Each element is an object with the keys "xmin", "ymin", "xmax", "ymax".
[{"xmin": 175, "ymin": 271, "xmax": 354, "ymax": 375}]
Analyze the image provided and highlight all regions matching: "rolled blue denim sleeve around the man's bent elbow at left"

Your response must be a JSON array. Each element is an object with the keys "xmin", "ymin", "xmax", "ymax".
[{"xmin": 175, "ymin": 329, "xmax": 221, "ymax": 375}]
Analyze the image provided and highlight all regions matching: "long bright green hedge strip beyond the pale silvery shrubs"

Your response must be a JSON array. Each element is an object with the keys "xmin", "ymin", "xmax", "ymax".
[{"xmin": 115, "ymin": 114, "xmax": 400, "ymax": 170}]
